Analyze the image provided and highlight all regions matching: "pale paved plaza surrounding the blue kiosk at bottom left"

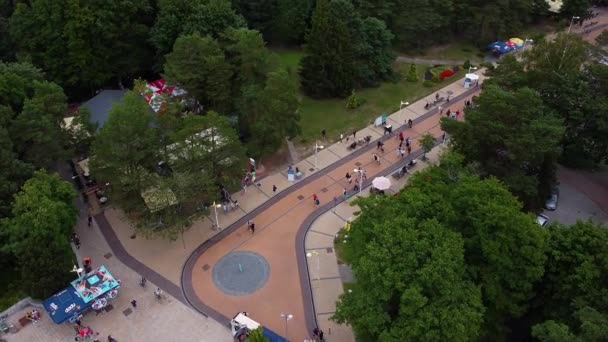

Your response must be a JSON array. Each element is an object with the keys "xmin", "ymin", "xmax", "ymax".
[{"xmin": 2, "ymin": 206, "xmax": 233, "ymax": 342}]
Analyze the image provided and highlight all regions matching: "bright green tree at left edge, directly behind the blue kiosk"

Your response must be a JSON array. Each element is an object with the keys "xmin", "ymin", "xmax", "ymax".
[{"xmin": 0, "ymin": 171, "xmax": 78, "ymax": 298}]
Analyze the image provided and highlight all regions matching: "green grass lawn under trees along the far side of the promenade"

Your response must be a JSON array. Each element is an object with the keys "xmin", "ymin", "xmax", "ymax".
[{"xmin": 277, "ymin": 50, "xmax": 464, "ymax": 144}]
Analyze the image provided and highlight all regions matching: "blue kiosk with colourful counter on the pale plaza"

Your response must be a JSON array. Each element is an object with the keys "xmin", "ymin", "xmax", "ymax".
[{"xmin": 42, "ymin": 266, "xmax": 120, "ymax": 324}]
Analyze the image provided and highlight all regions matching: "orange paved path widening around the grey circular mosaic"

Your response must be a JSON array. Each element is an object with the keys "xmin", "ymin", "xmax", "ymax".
[{"xmin": 182, "ymin": 89, "xmax": 478, "ymax": 341}]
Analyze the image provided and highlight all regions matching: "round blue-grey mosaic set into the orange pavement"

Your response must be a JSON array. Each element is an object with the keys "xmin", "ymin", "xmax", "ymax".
[{"xmin": 212, "ymin": 251, "xmax": 270, "ymax": 296}]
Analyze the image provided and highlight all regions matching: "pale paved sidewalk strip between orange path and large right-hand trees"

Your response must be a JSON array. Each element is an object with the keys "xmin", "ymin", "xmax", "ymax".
[{"xmin": 305, "ymin": 144, "xmax": 446, "ymax": 342}]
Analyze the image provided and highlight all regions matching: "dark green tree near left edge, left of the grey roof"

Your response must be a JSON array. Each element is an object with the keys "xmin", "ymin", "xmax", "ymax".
[{"xmin": 9, "ymin": 81, "xmax": 68, "ymax": 168}]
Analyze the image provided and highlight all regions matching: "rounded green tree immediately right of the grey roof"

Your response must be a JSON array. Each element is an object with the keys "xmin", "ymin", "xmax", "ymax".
[{"xmin": 90, "ymin": 91, "xmax": 160, "ymax": 196}]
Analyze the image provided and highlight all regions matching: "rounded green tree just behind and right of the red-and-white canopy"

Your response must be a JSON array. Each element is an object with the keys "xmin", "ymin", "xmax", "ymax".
[{"xmin": 164, "ymin": 33, "xmax": 232, "ymax": 110}]
